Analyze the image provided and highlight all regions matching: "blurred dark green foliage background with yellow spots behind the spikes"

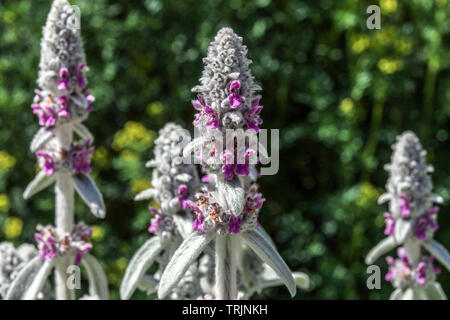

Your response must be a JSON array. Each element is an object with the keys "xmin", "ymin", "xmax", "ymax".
[{"xmin": 0, "ymin": 0, "xmax": 450, "ymax": 299}]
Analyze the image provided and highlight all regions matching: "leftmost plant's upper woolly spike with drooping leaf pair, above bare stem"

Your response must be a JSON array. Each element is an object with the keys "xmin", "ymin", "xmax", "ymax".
[{"xmin": 23, "ymin": 0, "xmax": 105, "ymax": 218}]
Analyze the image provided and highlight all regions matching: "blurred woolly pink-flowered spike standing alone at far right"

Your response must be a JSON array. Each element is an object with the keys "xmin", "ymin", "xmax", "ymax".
[{"xmin": 366, "ymin": 131, "xmax": 450, "ymax": 299}]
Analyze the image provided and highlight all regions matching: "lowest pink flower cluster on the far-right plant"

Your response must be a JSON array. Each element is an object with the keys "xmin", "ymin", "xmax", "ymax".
[{"xmin": 385, "ymin": 247, "xmax": 440, "ymax": 289}]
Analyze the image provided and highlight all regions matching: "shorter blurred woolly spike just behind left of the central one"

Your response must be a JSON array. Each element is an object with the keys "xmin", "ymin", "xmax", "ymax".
[{"xmin": 120, "ymin": 123, "xmax": 200, "ymax": 300}]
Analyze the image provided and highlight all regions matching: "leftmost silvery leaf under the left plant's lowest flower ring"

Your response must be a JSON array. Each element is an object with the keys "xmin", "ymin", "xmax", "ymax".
[{"xmin": 5, "ymin": 257, "xmax": 44, "ymax": 300}]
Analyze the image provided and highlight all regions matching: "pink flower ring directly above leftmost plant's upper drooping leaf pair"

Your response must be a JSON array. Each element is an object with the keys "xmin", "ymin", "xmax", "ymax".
[{"xmin": 36, "ymin": 138, "xmax": 94, "ymax": 176}]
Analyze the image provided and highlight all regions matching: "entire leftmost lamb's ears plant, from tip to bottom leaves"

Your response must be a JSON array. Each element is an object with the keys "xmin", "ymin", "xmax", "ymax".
[{"xmin": 7, "ymin": 0, "xmax": 108, "ymax": 300}]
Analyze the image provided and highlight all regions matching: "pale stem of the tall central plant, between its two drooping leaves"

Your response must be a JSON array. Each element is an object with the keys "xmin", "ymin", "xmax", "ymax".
[{"xmin": 216, "ymin": 234, "xmax": 237, "ymax": 300}]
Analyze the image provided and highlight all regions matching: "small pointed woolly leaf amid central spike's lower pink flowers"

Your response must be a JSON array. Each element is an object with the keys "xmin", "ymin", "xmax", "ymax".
[{"xmin": 215, "ymin": 177, "xmax": 245, "ymax": 217}]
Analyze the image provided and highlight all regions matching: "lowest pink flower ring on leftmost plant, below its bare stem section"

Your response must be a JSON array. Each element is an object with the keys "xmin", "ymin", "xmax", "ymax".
[{"xmin": 34, "ymin": 223, "xmax": 92, "ymax": 264}]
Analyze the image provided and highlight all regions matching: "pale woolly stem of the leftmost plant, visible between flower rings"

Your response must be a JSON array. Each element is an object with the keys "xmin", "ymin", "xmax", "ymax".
[{"xmin": 55, "ymin": 126, "xmax": 75, "ymax": 300}]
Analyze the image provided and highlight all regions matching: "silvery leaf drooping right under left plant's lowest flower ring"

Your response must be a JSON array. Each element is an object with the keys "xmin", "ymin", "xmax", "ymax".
[{"xmin": 81, "ymin": 253, "xmax": 109, "ymax": 300}]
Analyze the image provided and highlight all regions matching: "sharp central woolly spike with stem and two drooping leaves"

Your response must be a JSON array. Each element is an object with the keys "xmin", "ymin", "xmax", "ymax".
[{"xmin": 158, "ymin": 28, "xmax": 296, "ymax": 299}]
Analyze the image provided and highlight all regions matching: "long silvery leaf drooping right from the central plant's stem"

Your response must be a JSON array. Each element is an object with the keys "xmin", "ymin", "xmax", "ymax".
[{"xmin": 239, "ymin": 230, "xmax": 297, "ymax": 297}]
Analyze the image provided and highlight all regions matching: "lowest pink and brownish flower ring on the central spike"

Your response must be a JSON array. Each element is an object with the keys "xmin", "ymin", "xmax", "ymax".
[{"xmin": 187, "ymin": 184, "xmax": 265, "ymax": 234}]
